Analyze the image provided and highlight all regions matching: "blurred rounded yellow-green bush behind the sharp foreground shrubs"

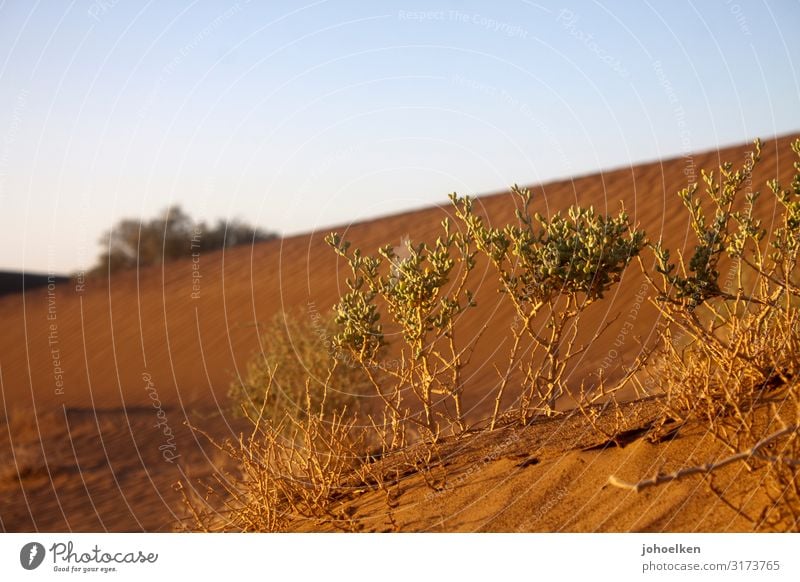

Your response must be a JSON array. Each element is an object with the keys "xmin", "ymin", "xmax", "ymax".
[{"xmin": 229, "ymin": 308, "xmax": 371, "ymax": 428}]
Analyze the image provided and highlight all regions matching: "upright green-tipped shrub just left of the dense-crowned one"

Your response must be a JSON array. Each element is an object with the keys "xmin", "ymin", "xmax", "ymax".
[{"xmin": 326, "ymin": 220, "xmax": 477, "ymax": 448}]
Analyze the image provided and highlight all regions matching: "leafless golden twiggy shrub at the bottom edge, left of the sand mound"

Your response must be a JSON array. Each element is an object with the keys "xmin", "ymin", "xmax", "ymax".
[{"xmin": 177, "ymin": 369, "xmax": 434, "ymax": 532}]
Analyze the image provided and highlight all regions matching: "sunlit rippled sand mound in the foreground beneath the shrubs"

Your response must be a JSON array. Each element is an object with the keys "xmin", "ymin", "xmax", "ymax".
[{"xmin": 324, "ymin": 401, "xmax": 764, "ymax": 532}]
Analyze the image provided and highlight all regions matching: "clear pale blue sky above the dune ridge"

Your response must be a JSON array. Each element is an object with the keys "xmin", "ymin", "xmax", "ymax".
[{"xmin": 0, "ymin": 0, "xmax": 800, "ymax": 272}]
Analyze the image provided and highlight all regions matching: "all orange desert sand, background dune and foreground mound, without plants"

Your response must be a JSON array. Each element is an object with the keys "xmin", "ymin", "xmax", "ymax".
[{"xmin": 0, "ymin": 136, "xmax": 796, "ymax": 531}]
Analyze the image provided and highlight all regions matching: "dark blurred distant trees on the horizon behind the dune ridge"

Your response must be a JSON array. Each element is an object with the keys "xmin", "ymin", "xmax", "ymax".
[{"xmin": 91, "ymin": 206, "xmax": 277, "ymax": 274}]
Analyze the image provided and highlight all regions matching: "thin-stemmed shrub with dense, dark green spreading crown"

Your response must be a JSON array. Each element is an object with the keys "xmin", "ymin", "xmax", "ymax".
[{"xmin": 451, "ymin": 186, "xmax": 645, "ymax": 426}]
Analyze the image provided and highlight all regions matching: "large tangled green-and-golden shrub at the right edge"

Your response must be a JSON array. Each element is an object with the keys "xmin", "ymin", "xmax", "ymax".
[{"xmin": 651, "ymin": 142, "xmax": 800, "ymax": 428}]
